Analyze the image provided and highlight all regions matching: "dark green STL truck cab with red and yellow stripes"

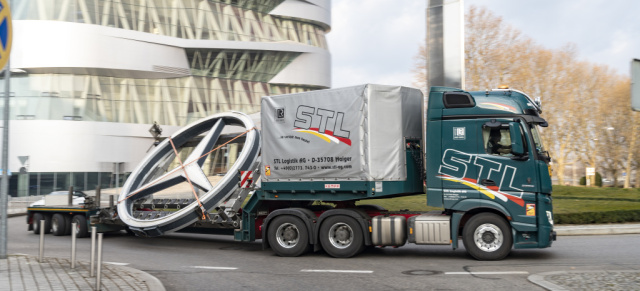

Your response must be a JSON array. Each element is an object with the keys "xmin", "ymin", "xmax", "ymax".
[{"xmin": 426, "ymin": 87, "xmax": 555, "ymax": 260}]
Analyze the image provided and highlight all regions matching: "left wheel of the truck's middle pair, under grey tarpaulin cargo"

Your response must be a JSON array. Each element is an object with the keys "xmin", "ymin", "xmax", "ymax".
[{"xmin": 267, "ymin": 215, "xmax": 310, "ymax": 257}]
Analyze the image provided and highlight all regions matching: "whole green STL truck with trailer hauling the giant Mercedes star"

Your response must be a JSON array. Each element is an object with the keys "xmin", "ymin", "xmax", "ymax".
[{"xmin": 27, "ymin": 84, "xmax": 556, "ymax": 260}]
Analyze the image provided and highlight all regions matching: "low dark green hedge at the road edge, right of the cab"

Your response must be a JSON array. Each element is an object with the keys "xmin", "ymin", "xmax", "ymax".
[{"xmin": 553, "ymin": 210, "xmax": 640, "ymax": 224}]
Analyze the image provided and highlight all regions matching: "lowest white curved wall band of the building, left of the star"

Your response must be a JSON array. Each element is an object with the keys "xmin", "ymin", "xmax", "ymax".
[{"xmin": 6, "ymin": 120, "xmax": 180, "ymax": 172}]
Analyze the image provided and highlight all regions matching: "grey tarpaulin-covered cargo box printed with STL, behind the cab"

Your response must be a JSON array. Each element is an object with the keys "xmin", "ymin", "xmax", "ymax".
[{"xmin": 261, "ymin": 84, "xmax": 423, "ymax": 182}]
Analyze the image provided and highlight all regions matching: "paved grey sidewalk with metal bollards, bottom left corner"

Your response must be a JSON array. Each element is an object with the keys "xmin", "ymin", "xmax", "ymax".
[{"xmin": 0, "ymin": 255, "xmax": 165, "ymax": 291}]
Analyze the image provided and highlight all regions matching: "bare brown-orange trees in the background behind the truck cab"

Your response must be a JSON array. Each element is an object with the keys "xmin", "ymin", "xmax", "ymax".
[{"xmin": 413, "ymin": 6, "xmax": 640, "ymax": 187}]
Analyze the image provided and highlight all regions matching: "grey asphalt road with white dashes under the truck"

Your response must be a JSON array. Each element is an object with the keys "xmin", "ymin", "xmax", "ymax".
[{"xmin": 8, "ymin": 216, "xmax": 640, "ymax": 290}]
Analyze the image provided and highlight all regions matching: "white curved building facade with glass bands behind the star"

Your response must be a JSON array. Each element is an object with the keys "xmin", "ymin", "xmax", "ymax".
[{"xmin": 9, "ymin": 0, "xmax": 331, "ymax": 196}]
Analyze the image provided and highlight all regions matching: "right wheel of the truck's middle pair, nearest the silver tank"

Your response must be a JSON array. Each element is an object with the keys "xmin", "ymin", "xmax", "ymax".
[{"xmin": 320, "ymin": 215, "xmax": 364, "ymax": 258}]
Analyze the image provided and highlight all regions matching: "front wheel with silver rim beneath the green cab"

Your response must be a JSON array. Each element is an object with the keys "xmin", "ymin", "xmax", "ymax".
[{"xmin": 462, "ymin": 213, "xmax": 513, "ymax": 261}]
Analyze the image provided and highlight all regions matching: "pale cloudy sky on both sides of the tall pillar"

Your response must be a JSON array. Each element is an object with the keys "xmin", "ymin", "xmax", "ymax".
[{"xmin": 327, "ymin": 0, "xmax": 640, "ymax": 88}]
